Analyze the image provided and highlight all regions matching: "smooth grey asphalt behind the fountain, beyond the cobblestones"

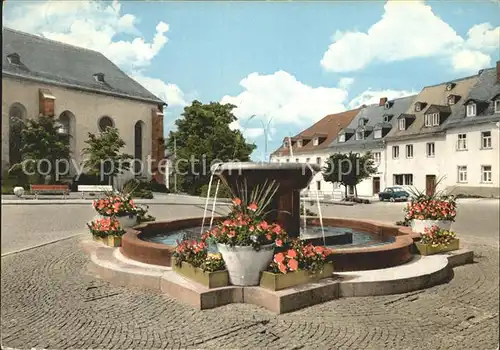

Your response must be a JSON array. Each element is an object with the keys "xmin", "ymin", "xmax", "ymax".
[{"xmin": 1, "ymin": 196, "xmax": 499, "ymax": 254}]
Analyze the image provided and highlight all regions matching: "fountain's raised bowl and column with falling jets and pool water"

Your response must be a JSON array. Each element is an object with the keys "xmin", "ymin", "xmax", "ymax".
[{"xmin": 144, "ymin": 163, "xmax": 390, "ymax": 248}]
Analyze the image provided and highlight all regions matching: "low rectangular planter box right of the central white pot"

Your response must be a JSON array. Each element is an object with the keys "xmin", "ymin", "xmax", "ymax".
[{"xmin": 260, "ymin": 262, "xmax": 333, "ymax": 291}]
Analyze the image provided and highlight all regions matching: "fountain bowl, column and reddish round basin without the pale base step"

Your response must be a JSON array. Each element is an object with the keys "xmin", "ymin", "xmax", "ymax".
[{"xmin": 121, "ymin": 162, "xmax": 413, "ymax": 271}]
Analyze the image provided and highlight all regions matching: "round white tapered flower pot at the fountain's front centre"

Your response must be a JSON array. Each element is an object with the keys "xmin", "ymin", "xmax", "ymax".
[{"xmin": 217, "ymin": 243, "xmax": 274, "ymax": 286}]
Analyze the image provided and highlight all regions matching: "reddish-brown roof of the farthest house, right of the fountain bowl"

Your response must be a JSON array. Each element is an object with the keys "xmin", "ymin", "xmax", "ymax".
[{"xmin": 272, "ymin": 108, "xmax": 360, "ymax": 156}]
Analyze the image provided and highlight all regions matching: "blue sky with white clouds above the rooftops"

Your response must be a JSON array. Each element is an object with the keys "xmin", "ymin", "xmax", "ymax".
[{"xmin": 3, "ymin": 0, "xmax": 500, "ymax": 160}]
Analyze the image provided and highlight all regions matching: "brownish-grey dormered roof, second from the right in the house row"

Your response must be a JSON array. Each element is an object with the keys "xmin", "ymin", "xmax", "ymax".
[{"xmin": 386, "ymin": 75, "xmax": 478, "ymax": 140}]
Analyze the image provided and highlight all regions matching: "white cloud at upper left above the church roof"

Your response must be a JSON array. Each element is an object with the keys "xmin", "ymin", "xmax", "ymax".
[{"xmin": 4, "ymin": 1, "xmax": 185, "ymax": 105}]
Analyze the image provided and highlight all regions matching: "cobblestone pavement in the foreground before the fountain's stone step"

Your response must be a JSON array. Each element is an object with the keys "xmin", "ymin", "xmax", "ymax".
[{"xmin": 1, "ymin": 238, "xmax": 499, "ymax": 350}]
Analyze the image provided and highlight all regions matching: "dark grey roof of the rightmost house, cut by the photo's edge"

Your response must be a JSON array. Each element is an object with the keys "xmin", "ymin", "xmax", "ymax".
[{"xmin": 447, "ymin": 68, "xmax": 500, "ymax": 128}]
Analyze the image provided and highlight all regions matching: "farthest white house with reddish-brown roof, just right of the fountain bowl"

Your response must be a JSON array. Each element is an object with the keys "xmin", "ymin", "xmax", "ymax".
[{"xmin": 270, "ymin": 109, "xmax": 360, "ymax": 199}]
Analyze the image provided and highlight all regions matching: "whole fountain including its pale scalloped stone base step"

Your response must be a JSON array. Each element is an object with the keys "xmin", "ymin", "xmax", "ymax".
[{"xmin": 86, "ymin": 163, "xmax": 473, "ymax": 313}]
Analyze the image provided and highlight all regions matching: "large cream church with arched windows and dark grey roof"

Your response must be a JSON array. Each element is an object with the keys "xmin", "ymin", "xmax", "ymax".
[{"xmin": 2, "ymin": 28, "xmax": 166, "ymax": 183}]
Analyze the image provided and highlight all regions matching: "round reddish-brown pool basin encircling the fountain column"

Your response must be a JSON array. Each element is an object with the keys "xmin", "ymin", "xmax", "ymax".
[{"xmin": 121, "ymin": 218, "xmax": 413, "ymax": 271}]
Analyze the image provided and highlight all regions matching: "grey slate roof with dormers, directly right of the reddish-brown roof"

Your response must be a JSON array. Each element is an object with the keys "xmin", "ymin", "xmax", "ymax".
[{"xmin": 330, "ymin": 95, "xmax": 416, "ymax": 150}]
